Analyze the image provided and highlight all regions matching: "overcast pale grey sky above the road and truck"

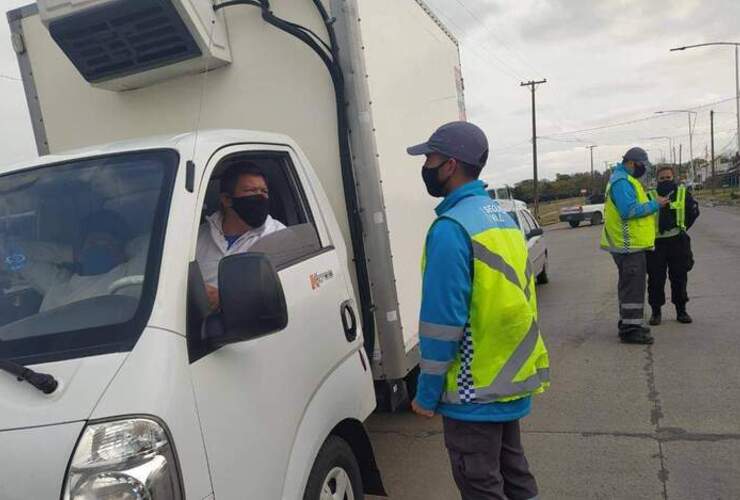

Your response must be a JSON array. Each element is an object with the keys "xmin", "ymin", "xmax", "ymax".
[{"xmin": 0, "ymin": 0, "xmax": 740, "ymax": 183}]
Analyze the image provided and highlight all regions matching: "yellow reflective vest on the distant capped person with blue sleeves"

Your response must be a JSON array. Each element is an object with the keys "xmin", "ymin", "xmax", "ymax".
[{"xmin": 601, "ymin": 171, "xmax": 656, "ymax": 253}]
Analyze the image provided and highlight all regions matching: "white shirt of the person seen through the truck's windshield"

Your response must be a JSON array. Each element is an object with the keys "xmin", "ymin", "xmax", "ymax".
[{"xmin": 22, "ymin": 235, "xmax": 148, "ymax": 312}]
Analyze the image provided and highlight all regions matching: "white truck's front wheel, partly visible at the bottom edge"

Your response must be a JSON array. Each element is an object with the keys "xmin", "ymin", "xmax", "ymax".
[{"xmin": 303, "ymin": 436, "xmax": 364, "ymax": 500}]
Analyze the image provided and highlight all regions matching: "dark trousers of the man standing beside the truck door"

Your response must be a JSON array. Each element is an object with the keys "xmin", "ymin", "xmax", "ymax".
[{"xmin": 444, "ymin": 417, "xmax": 537, "ymax": 500}]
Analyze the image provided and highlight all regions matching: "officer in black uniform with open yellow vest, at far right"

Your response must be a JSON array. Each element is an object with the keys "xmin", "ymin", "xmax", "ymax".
[{"xmin": 647, "ymin": 165, "xmax": 699, "ymax": 326}]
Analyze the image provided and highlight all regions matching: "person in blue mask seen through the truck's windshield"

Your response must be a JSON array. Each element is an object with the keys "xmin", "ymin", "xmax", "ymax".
[{"xmin": 6, "ymin": 210, "xmax": 146, "ymax": 312}]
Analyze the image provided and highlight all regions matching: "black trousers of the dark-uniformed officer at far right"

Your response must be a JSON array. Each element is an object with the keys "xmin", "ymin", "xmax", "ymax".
[{"xmin": 647, "ymin": 233, "xmax": 694, "ymax": 309}]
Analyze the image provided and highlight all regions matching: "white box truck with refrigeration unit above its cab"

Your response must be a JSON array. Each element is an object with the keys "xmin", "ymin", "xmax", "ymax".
[{"xmin": 0, "ymin": 0, "xmax": 464, "ymax": 500}]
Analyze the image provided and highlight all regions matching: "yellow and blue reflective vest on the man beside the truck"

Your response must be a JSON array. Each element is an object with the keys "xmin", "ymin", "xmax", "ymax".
[{"xmin": 424, "ymin": 196, "xmax": 550, "ymax": 404}]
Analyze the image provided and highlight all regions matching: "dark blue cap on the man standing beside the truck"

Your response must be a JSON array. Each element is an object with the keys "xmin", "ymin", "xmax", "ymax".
[{"xmin": 406, "ymin": 122, "xmax": 488, "ymax": 168}]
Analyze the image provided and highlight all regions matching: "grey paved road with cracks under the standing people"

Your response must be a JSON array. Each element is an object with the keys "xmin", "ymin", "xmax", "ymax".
[{"xmin": 369, "ymin": 208, "xmax": 740, "ymax": 500}]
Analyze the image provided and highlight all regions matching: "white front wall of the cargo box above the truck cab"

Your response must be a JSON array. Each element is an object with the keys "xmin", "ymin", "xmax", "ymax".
[{"xmin": 13, "ymin": 0, "xmax": 353, "ymax": 258}]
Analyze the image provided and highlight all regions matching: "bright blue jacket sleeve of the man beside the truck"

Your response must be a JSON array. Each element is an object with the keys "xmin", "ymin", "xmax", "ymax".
[{"xmin": 416, "ymin": 219, "xmax": 473, "ymax": 410}]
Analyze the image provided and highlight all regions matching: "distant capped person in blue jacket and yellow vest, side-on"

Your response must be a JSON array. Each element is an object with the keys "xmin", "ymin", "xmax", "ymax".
[{"xmin": 601, "ymin": 148, "xmax": 668, "ymax": 344}]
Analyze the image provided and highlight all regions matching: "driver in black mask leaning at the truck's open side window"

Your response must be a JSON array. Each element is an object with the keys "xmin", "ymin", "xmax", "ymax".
[{"xmin": 196, "ymin": 162, "xmax": 285, "ymax": 310}]
